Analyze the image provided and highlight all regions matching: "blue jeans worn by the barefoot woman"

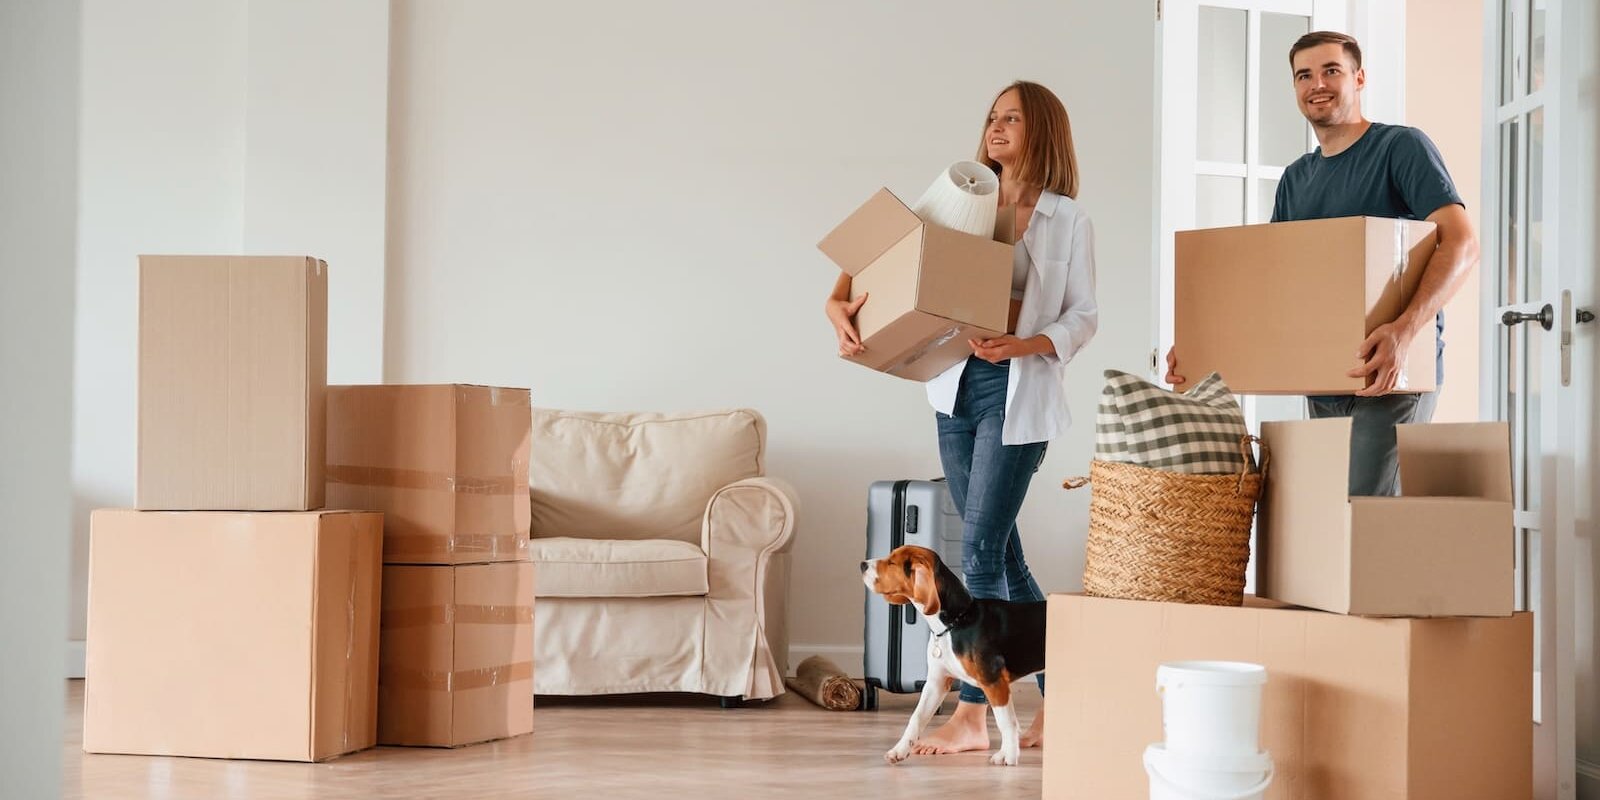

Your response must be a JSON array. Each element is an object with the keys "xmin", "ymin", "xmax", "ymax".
[{"xmin": 936, "ymin": 355, "xmax": 1046, "ymax": 702}]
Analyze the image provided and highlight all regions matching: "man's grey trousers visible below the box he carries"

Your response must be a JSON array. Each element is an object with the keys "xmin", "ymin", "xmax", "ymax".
[{"xmin": 1306, "ymin": 392, "xmax": 1438, "ymax": 498}]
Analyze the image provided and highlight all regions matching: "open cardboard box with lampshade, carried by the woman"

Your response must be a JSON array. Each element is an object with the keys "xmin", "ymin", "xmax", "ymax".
[{"xmin": 818, "ymin": 189, "xmax": 1013, "ymax": 381}]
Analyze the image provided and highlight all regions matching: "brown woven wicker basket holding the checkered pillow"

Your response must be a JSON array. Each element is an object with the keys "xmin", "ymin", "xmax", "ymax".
[{"xmin": 1064, "ymin": 437, "xmax": 1267, "ymax": 605}]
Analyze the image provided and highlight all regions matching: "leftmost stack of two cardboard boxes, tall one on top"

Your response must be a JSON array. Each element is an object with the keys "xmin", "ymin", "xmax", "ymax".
[{"xmin": 83, "ymin": 256, "xmax": 382, "ymax": 762}]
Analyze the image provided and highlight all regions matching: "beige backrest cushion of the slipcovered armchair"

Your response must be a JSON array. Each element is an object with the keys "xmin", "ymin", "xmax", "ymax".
[{"xmin": 528, "ymin": 408, "xmax": 766, "ymax": 547}]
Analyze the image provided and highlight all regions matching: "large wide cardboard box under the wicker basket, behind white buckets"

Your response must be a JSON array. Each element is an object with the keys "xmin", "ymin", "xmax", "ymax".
[{"xmin": 1043, "ymin": 594, "xmax": 1533, "ymax": 800}]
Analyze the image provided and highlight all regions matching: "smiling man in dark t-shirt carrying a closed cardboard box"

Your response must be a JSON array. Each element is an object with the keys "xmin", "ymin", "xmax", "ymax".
[{"xmin": 1166, "ymin": 30, "xmax": 1478, "ymax": 496}]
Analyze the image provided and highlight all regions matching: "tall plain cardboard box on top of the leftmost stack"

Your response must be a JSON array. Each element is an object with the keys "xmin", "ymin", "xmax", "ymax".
[{"xmin": 136, "ymin": 256, "xmax": 328, "ymax": 510}]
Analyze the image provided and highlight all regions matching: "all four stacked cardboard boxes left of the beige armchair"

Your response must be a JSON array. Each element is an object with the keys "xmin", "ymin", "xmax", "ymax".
[{"xmin": 83, "ymin": 256, "xmax": 533, "ymax": 762}]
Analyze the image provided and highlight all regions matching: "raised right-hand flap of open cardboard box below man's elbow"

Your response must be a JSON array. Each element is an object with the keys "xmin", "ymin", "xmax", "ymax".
[{"xmin": 1395, "ymin": 422, "xmax": 1512, "ymax": 502}]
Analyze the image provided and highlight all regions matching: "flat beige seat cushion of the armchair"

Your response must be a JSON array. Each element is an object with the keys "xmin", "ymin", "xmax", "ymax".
[{"xmin": 531, "ymin": 536, "xmax": 707, "ymax": 597}]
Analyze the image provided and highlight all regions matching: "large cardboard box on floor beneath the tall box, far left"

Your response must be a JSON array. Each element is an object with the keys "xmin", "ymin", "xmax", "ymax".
[{"xmin": 83, "ymin": 510, "xmax": 382, "ymax": 762}]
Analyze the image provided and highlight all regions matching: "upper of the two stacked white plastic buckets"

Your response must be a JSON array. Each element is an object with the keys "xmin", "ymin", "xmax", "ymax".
[{"xmin": 1155, "ymin": 661, "xmax": 1267, "ymax": 757}]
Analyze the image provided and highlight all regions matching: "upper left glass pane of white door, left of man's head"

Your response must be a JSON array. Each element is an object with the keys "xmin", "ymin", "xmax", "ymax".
[{"xmin": 1195, "ymin": 6, "xmax": 1246, "ymax": 163}]
